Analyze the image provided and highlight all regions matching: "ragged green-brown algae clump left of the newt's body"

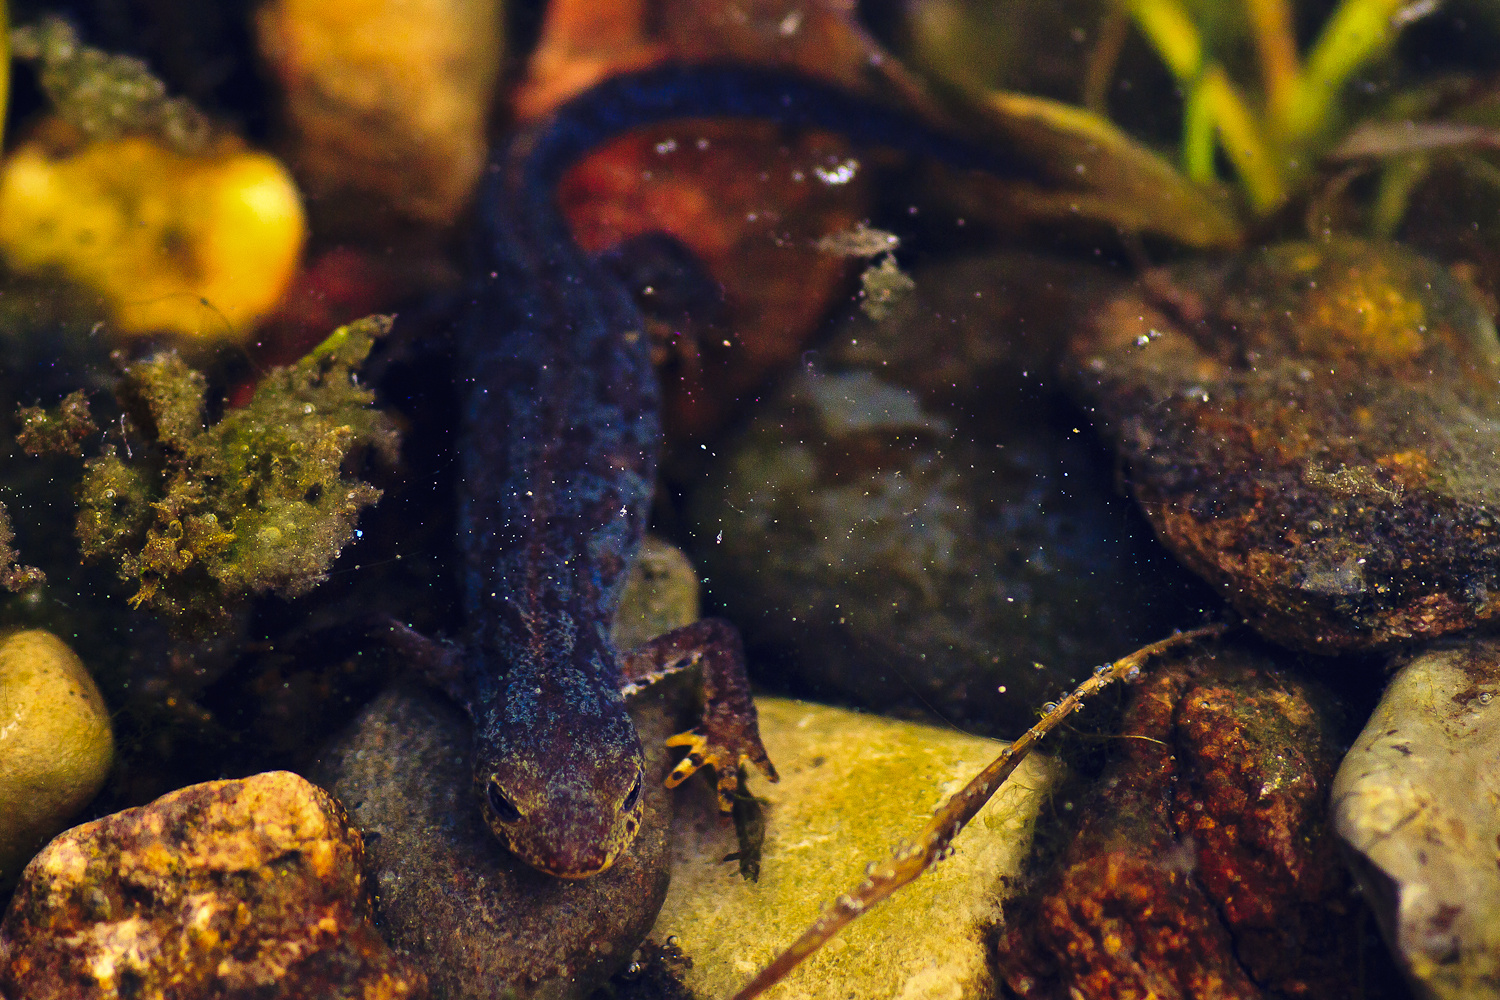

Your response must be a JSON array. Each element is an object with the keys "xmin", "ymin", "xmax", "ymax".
[{"xmin": 49, "ymin": 316, "xmax": 398, "ymax": 631}]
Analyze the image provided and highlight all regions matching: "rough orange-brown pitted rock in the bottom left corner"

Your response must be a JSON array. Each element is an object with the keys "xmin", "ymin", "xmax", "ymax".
[{"xmin": 0, "ymin": 771, "xmax": 428, "ymax": 1000}]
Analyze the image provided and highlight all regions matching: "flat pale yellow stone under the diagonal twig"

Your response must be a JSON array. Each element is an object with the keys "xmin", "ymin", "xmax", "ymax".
[{"xmin": 651, "ymin": 699, "xmax": 1055, "ymax": 1000}]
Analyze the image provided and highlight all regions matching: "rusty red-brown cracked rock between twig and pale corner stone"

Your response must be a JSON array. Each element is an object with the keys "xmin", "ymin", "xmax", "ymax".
[{"xmin": 998, "ymin": 645, "xmax": 1359, "ymax": 1000}]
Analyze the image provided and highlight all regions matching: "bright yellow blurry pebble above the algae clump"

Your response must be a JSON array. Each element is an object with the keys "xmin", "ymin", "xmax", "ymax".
[{"xmin": 0, "ymin": 128, "xmax": 306, "ymax": 342}]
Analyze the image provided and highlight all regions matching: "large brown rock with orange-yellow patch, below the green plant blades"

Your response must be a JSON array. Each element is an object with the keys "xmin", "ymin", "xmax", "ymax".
[{"xmin": 1068, "ymin": 240, "xmax": 1500, "ymax": 652}]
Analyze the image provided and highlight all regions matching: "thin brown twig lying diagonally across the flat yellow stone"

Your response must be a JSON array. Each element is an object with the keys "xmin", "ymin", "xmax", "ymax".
[{"xmin": 732, "ymin": 625, "xmax": 1229, "ymax": 1000}]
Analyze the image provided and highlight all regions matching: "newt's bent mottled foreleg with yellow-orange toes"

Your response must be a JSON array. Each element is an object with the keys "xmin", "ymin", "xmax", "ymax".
[{"xmin": 620, "ymin": 618, "xmax": 777, "ymax": 813}]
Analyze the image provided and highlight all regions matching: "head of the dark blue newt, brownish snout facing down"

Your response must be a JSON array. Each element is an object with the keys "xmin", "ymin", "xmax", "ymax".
[{"xmin": 474, "ymin": 659, "xmax": 645, "ymax": 879}]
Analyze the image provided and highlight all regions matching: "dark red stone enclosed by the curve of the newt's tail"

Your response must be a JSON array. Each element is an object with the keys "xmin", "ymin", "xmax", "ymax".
[{"xmin": 558, "ymin": 121, "xmax": 872, "ymax": 439}]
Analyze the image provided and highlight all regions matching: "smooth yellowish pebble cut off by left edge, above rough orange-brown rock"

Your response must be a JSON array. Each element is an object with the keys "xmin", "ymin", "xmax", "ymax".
[{"xmin": 0, "ymin": 631, "xmax": 114, "ymax": 892}]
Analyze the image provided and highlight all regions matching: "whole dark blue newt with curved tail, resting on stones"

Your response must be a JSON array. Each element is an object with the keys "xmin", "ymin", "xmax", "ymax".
[{"xmin": 399, "ymin": 66, "xmax": 1014, "ymax": 879}]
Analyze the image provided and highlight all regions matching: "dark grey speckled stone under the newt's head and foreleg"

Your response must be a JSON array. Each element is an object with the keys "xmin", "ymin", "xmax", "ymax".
[{"xmin": 317, "ymin": 540, "xmax": 698, "ymax": 1000}]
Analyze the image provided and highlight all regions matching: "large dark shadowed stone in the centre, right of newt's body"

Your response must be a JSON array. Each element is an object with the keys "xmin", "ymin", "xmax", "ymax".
[{"xmin": 692, "ymin": 258, "xmax": 1212, "ymax": 730}]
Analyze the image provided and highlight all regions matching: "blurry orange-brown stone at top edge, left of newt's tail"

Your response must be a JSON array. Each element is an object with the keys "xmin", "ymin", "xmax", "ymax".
[{"xmin": 257, "ymin": 0, "xmax": 504, "ymax": 231}]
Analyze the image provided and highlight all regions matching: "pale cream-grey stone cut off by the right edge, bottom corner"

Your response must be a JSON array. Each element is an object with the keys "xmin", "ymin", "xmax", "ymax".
[{"xmin": 1334, "ymin": 640, "xmax": 1500, "ymax": 1000}]
